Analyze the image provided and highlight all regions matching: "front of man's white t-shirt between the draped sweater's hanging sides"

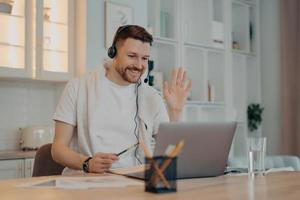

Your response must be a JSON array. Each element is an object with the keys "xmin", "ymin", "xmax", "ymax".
[{"xmin": 92, "ymin": 77, "xmax": 138, "ymax": 167}]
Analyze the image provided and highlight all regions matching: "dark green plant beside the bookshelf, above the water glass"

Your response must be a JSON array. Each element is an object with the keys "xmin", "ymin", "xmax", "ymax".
[{"xmin": 247, "ymin": 103, "xmax": 264, "ymax": 132}]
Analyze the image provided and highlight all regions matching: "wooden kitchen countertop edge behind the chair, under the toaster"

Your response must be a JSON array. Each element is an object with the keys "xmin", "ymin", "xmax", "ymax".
[{"xmin": 0, "ymin": 150, "xmax": 36, "ymax": 160}]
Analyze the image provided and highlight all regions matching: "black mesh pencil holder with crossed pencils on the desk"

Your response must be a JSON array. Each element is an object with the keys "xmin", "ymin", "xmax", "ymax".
[{"xmin": 145, "ymin": 156, "xmax": 177, "ymax": 193}]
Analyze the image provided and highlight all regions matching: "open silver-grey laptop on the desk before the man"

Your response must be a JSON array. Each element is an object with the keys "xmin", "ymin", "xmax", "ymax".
[{"xmin": 128, "ymin": 122, "xmax": 236, "ymax": 178}]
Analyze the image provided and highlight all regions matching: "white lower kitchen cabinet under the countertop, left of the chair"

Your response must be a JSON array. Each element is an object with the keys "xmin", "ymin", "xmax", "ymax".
[{"xmin": 0, "ymin": 158, "xmax": 34, "ymax": 180}]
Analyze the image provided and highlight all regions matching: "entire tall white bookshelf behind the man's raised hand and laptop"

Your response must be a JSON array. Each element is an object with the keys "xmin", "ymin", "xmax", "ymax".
[{"xmin": 148, "ymin": 0, "xmax": 261, "ymax": 159}]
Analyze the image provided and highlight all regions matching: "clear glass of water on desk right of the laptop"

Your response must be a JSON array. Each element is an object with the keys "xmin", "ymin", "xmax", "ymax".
[{"xmin": 248, "ymin": 137, "xmax": 267, "ymax": 177}]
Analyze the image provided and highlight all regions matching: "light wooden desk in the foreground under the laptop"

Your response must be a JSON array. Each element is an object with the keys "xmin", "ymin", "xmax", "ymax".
[{"xmin": 0, "ymin": 172, "xmax": 300, "ymax": 200}]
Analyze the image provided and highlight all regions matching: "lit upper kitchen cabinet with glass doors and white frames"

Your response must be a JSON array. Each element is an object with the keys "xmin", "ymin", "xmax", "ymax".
[{"xmin": 0, "ymin": 0, "xmax": 75, "ymax": 81}]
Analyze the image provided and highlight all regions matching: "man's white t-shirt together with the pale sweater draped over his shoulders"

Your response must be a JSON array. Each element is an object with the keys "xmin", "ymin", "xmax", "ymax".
[{"xmin": 53, "ymin": 69, "xmax": 169, "ymax": 171}]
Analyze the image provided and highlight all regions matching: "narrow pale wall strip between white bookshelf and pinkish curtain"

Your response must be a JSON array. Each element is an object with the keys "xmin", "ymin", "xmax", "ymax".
[{"xmin": 260, "ymin": 0, "xmax": 281, "ymax": 154}]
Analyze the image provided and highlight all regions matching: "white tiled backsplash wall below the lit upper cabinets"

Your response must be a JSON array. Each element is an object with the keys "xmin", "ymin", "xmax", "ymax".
[{"xmin": 0, "ymin": 80, "xmax": 64, "ymax": 150}]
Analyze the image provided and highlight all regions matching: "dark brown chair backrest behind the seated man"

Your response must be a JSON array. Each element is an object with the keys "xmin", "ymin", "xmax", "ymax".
[{"xmin": 32, "ymin": 144, "xmax": 64, "ymax": 177}]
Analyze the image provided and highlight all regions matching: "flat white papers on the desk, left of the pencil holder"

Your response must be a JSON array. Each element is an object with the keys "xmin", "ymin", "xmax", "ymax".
[{"xmin": 19, "ymin": 175, "xmax": 144, "ymax": 189}]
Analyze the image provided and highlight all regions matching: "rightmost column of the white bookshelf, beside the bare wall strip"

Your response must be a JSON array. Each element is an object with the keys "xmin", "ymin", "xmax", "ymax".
[{"xmin": 232, "ymin": 0, "xmax": 261, "ymax": 156}]
